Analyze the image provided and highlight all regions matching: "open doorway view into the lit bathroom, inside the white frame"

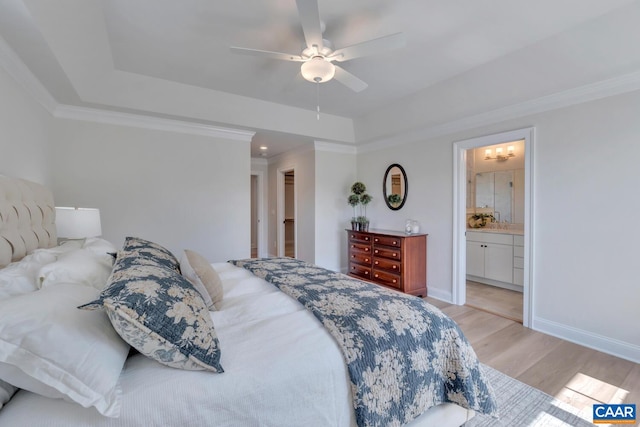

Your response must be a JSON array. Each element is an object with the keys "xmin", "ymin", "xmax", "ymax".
[{"xmin": 466, "ymin": 140, "xmax": 525, "ymax": 323}]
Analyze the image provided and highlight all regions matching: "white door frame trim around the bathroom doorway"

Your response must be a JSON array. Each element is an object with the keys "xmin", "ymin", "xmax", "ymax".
[{"xmin": 452, "ymin": 127, "xmax": 535, "ymax": 327}]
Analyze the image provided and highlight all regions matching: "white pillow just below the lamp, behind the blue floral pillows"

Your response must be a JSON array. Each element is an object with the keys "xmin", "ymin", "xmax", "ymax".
[{"xmin": 38, "ymin": 249, "xmax": 113, "ymax": 290}]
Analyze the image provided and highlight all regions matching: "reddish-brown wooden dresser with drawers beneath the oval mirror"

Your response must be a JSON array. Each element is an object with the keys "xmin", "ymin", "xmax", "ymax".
[{"xmin": 346, "ymin": 230, "xmax": 427, "ymax": 296}]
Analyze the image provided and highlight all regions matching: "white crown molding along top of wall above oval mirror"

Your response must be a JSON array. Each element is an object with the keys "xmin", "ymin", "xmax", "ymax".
[{"xmin": 357, "ymin": 71, "xmax": 640, "ymax": 153}]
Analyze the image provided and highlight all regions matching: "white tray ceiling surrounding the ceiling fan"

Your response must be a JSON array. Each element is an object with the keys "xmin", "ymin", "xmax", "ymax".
[{"xmin": 0, "ymin": 0, "xmax": 640, "ymax": 156}]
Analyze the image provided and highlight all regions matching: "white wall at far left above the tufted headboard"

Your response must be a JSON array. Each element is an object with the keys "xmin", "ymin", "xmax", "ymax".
[{"xmin": 0, "ymin": 67, "xmax": 53, "ymax": 185}]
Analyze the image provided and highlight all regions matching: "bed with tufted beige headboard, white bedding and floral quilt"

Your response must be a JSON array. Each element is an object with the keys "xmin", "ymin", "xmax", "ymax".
[{"xmin": 0, "ymin": 176, "xmax": 497, "ymax": 427}]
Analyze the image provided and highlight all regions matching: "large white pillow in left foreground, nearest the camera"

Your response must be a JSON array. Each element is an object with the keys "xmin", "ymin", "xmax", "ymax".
[{"xmin": 0, "ymin": 284, "xmax": 129, "ymax": 417}]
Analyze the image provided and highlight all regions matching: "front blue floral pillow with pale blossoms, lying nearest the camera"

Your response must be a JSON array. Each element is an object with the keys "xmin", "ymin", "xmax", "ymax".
[{"xmin": 79, "ymin": 252, "xmax": 224, "ymax": 372}]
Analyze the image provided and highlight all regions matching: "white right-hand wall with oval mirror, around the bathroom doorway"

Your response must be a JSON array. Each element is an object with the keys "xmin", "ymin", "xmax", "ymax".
[{"xmin": 357, "ymin": 92, "xmax": 640, "ymax": 361}]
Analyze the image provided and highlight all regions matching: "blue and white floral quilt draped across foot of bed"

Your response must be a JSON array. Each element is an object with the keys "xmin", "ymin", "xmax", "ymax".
[{"xmin": 230, "ymin": 258, "xmax": 497, "ymax": 426}]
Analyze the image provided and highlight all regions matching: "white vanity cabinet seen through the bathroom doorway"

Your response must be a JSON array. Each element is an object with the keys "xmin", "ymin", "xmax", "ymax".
[{"xmin": 467, "ymin": 231, "xmax": 522, "ymax": 290}]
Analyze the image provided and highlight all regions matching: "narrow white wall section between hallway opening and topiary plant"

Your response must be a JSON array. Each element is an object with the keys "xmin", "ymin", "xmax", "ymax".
[{"xmin": 315, "ymin": 149, "xmax": 356, "ymax": 272}]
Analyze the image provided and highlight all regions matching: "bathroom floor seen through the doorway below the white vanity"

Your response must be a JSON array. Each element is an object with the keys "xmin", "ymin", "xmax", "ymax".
[{"xmin": 466, "ymin": 280, "xmax": 522, "ymax": 323}]
